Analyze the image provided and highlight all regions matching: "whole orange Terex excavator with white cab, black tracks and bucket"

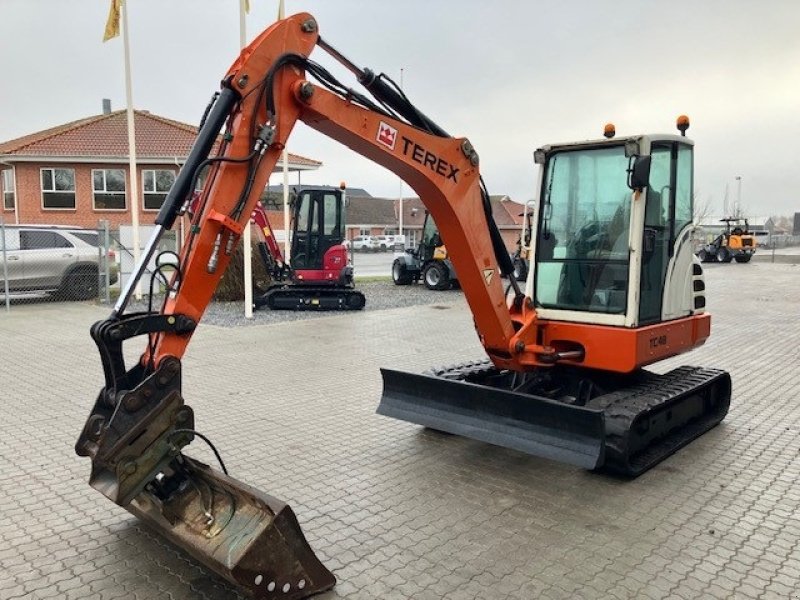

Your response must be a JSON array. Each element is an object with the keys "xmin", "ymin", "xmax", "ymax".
[{"xmin": 76, "ymin": 13, "xmax": 731, "ymax": 598}]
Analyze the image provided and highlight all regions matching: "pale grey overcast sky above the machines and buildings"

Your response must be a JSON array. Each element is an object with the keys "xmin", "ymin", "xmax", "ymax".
[{"xmin": 0, "ymin": 0, "xmax": 800, "ymax": 216}]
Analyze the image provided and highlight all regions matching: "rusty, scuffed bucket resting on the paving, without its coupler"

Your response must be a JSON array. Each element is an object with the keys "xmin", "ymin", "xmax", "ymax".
[{"xmin": 125, "ymin": 455, "xmax": 336, "ymax": 600}]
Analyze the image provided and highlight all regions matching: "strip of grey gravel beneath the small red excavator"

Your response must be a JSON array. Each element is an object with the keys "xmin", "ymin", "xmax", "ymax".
[{"xmin": 128, "ymin": 281, "xmax": 463, "ymax": 327}]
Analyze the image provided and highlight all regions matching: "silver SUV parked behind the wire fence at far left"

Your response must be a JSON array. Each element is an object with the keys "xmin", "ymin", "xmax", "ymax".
[{"xmin": 0, "ymin": 225, "xmax": 118, "ymax": 300}]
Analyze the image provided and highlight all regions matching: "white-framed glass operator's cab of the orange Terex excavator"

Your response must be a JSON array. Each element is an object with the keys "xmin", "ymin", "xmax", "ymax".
[{"xmin": 531, "ymin": 136, "xmax": 702, "ymax": 327}]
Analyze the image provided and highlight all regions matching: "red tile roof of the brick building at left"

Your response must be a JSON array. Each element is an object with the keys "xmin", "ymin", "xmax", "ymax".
[{"xmin": 0, "ymin": 110, "xmax": 322, "ymax": 168}]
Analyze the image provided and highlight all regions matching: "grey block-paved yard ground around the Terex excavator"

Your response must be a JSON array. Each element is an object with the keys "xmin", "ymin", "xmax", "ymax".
[{"xmin": 0, "ymin": 263, "xmax": 800, "ymax": 600}]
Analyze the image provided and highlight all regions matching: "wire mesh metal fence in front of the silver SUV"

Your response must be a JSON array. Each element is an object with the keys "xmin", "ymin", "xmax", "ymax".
[{"xmin": 0, "ymin": 217, "xmax": 178, "ymax": 311}]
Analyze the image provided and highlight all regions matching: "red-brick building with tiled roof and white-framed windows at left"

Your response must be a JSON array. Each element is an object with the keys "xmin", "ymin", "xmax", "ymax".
[{"xmin": 0, "ymin": 109, "xmax": 322, "ymax": 228}]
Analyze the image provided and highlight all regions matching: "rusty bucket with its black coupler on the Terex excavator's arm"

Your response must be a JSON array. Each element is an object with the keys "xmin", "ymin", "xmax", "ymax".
[{"xmin": 76, "ymin": 346, "xmax": 336, "ymax": 600}]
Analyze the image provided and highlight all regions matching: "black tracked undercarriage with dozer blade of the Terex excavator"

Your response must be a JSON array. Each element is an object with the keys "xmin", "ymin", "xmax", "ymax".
[{"xmin": 378, "ymin": 361, "xmax": 731, "ymax": 477}]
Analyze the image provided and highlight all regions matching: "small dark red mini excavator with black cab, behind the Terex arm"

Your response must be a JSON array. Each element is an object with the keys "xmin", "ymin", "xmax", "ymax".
[{"xmin": 251, "ymin": 187, "xmax": 366, "ymax": 310}]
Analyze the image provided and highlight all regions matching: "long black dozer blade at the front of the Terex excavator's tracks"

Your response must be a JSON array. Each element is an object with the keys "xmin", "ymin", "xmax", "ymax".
[{"xmin": 377, "ymin": 369, "xmax": 605, "ymax": 469}]
